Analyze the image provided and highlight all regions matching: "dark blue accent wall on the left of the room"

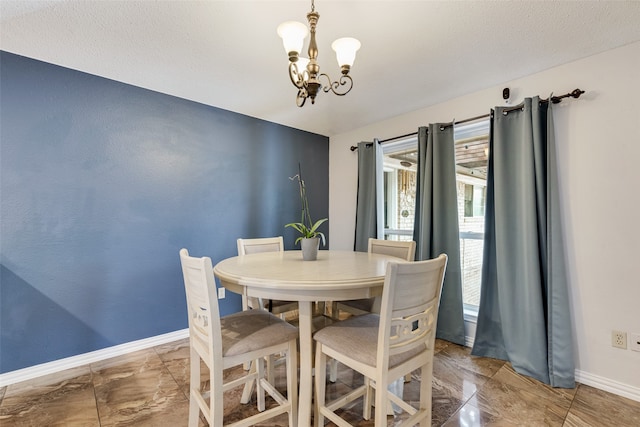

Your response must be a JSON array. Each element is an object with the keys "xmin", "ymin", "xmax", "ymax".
[{"xmin": 0, "ymin": 52, "xmax": 329, "ymax": 373}]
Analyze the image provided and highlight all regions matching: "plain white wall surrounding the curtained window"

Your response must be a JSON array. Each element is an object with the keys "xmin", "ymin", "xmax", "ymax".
[{"xmin": 329, "ymin": 42, "xmax": 640, "ymax": 400}]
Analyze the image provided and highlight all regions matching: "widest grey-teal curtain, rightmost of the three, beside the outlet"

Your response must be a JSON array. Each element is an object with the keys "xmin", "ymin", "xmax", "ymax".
[{"xmin": 472, "ymin": 97, "xmax": 575, "ymax": 388}]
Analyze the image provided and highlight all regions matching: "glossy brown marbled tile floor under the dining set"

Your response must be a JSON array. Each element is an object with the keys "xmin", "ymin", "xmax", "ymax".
[{"xmin": 0, "ymin": 340, "xmax": 640, "ymax": 427}]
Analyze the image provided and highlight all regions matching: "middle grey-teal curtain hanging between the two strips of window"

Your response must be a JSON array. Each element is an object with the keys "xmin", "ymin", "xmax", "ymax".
[{"xmin": 413, "ymin": 123, "xmax": 465, "ymax": 345}]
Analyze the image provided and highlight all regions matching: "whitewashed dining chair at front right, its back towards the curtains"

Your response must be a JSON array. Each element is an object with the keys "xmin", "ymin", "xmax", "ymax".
[{"xmin": 314, "ymin": 254, "xmax": 447, "ymax": 427}]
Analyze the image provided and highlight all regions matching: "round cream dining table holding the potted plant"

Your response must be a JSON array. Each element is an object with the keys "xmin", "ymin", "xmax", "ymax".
[{"xmin": 213, "ymin": 250, "xmax": 398, "ymax": 427}]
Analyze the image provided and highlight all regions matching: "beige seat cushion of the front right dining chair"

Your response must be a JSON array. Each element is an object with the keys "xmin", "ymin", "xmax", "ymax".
[{"xmin": 313, "ymin": 314, "xmax": 424, "ymax": 368}]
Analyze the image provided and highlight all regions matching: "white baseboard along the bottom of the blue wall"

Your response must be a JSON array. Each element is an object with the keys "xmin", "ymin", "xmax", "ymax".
[{"xmin": 0, "ymin": 328, "xmax": 189, "ymax": 387}]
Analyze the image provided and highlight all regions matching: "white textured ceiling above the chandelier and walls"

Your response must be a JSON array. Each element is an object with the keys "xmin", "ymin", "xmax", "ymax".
[{"xmin": 0, "ymin": 0, "xmax": 640, "ymax": 136}]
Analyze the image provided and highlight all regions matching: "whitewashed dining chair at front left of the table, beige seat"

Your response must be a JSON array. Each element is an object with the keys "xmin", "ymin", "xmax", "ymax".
[{"xmin": 180, "ymin": 248, "xmax": 298, "ymax": 427}]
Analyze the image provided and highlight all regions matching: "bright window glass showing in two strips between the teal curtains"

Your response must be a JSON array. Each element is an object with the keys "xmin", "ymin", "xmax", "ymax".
[{"xmin": 382, "ymin": 120, "xmax": 489, "ymax": 313}]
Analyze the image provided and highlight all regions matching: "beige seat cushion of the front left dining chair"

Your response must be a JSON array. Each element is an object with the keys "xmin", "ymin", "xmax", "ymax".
[{"xmin": 220, "ymin": 310, "xmax": 298, "ymax": 356}]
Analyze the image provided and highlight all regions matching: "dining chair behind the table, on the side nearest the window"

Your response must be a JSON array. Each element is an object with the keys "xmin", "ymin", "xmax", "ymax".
[{"xmin": 331, "ymin": 238, "xmax": 416, "ymax": 320}]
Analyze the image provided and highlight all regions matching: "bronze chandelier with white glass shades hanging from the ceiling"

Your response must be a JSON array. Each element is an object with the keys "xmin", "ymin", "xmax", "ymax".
[{"xmin": 278, "ymin": 0, "xmax": 360, "ymax": 107}]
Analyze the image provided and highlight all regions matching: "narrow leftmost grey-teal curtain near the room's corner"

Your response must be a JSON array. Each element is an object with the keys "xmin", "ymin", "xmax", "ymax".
[{"xmin": 353, "ymin": 140, "xmax": 384, "ymax": 252}]
